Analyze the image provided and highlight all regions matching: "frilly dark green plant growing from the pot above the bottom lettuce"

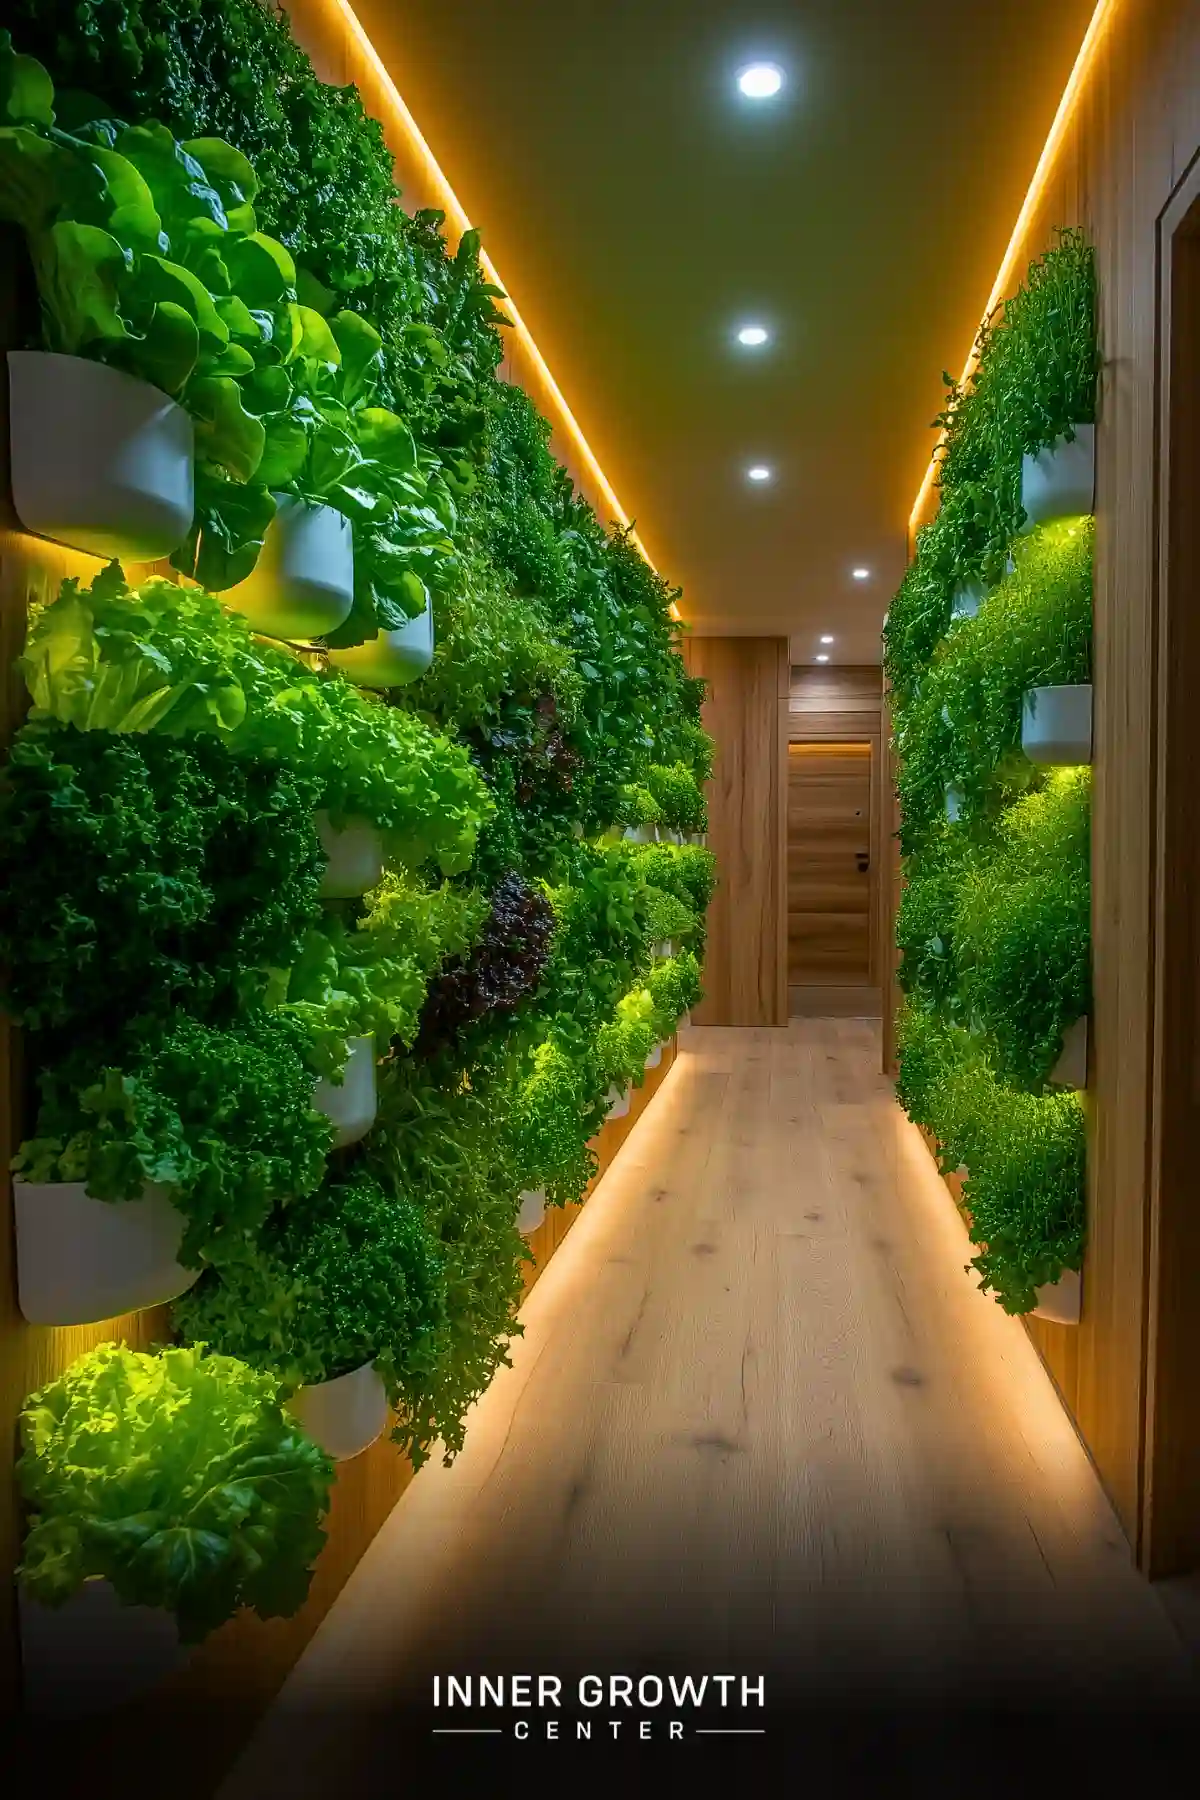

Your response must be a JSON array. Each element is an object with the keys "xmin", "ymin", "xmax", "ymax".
[{"xmin": 14, "ymin": 1012, "xmax": 333, "ymax": 1269}]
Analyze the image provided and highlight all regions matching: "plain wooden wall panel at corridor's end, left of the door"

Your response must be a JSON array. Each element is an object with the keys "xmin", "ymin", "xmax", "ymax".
[{"xmin": 684, "ymin": 637, "xmax": 788, "ymax": 1024}]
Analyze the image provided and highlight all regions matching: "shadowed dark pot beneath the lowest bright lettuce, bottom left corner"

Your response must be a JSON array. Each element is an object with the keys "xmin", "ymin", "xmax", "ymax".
[{"xmin": 16, "ymin": 1577, "xmax": 189, "ymax": 1719}]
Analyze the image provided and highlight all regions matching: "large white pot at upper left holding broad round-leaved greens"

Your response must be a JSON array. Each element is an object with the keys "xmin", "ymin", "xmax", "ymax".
[{"xmin": 9, "ymin": 349, "xmax": 194, "ymax": 562}]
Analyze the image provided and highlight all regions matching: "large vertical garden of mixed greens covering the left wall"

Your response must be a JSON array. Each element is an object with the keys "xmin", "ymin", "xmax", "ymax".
[{"xmin": 0, "ymin": 0, "xmax": 714, "ymax": 1640}]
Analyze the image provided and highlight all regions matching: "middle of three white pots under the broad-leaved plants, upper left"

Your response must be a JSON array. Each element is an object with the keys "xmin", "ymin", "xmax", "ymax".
[{"xmin": 221, "ymin": 493, "xmax": 354, "ymax": 643}]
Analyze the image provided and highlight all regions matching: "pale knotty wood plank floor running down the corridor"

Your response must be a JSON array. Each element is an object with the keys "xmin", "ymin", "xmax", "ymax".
[{"xmin": 221, "ymin": 1019, "xmax": 1195, "ymax": 1800}]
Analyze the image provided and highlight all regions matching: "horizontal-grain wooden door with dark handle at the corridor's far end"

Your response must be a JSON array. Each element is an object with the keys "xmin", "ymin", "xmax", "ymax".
[{"xmin": 788, "ymin": 743, "xmax": 873, "ymax": 988}]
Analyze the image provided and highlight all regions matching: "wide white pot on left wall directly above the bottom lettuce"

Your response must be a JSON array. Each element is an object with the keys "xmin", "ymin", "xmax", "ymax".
[{"xmin": 13, "ymin": 1177, "xmax": 200, "ymax": 1325}]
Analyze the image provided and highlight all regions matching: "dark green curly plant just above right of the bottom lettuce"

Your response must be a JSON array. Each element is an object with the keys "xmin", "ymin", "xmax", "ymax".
[{"xmin": 171, "ymin": 1168, "xmax": 446, "ymax": 1404}]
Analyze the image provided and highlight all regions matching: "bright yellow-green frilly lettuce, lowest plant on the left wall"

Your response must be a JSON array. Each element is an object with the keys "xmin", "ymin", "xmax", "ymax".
[{"xmin": 16, "ymin": 1343, "xmax": 333, "ymax": 1643}]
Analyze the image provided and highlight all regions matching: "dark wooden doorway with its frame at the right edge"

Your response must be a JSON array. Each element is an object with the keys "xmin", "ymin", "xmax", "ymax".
[{"xmin": 1137, "ymin": 160, "xmax": 1200, "ymax": 1577}]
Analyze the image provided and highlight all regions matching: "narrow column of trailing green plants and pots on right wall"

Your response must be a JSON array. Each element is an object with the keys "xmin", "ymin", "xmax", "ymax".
[{"xmin": 883, "ymin": 232, "xmax": 1097, "ymax": 1321}]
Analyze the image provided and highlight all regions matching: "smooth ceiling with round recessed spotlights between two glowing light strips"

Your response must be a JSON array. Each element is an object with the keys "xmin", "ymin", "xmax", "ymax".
[{"xmin": 356, "ymin": 0, "xmax": 1094, "ymax": 662}]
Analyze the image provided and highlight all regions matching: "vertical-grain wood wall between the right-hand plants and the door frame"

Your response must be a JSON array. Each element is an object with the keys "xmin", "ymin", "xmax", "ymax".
[{"xmin": 899, "ymin": 0, "xmax": 1200, "ymax": 1553}]
